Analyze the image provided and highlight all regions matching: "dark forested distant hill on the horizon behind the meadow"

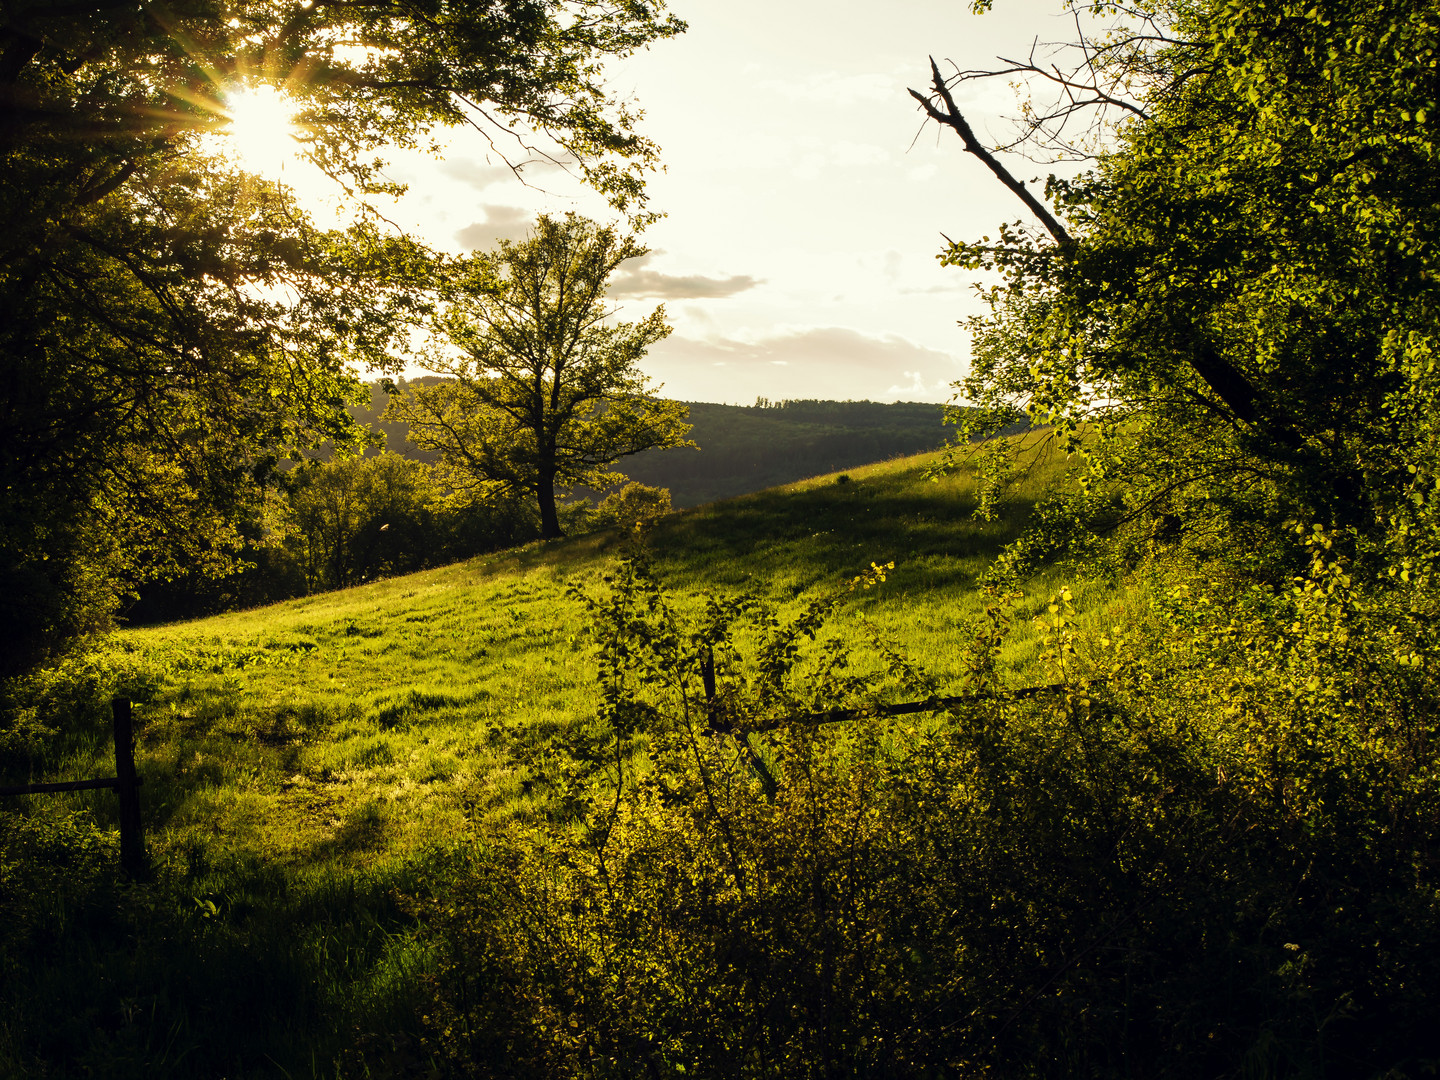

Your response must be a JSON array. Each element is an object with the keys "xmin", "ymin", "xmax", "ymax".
[{"xmin": 356, "ymin": 380, "xmax": 953, "ymax": 507}]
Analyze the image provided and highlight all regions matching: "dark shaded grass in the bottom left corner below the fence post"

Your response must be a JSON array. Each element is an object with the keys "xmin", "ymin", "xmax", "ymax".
[{"xmin": 0, "ymin": 808, "xmax": 452, "ymax": 1080}]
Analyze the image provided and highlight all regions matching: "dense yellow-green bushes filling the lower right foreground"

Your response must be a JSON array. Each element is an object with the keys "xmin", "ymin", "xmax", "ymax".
[{"xmin": 417, "ymin": 531, "xmax": 1440, "ymax": 1077}]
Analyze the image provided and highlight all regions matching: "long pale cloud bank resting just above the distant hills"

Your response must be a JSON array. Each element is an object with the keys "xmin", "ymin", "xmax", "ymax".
[{"xmin": 644, "ymin": 327, "xmax": 963, "ymax": 405}]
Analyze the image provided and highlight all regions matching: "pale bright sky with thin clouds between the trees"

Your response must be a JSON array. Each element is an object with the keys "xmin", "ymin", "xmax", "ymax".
[{"xmin": 250, "ymin": 0, "xmax": 1070, "ymax": 405}]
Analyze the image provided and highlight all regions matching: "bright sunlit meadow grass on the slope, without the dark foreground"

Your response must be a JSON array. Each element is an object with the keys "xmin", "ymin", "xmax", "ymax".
[{"xmin": 109, "ymin": 440, "xmax": 1060, "ymax": 863}]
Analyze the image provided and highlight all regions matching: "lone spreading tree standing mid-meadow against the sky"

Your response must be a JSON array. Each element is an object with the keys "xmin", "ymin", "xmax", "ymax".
[{"xmin": 390, "ymin": 215, "xmax": 690, "ymax": 539}]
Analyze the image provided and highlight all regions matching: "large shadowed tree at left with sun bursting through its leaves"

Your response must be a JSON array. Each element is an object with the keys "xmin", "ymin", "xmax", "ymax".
[{"xmin": 0, "ymin": 0, "xmax": 683, "ymax": 667}]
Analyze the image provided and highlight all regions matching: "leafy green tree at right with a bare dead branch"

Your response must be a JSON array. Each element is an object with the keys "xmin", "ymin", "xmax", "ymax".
[{"xmin": 912, "ymin": 0, "xmax": 1440, "ymax": 552}]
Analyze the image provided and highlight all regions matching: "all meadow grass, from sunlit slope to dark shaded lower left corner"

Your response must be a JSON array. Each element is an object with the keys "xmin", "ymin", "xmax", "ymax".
[{"xmin": 0, "ymin": 434, "xmax": 1084, "ymax": 1077}]
